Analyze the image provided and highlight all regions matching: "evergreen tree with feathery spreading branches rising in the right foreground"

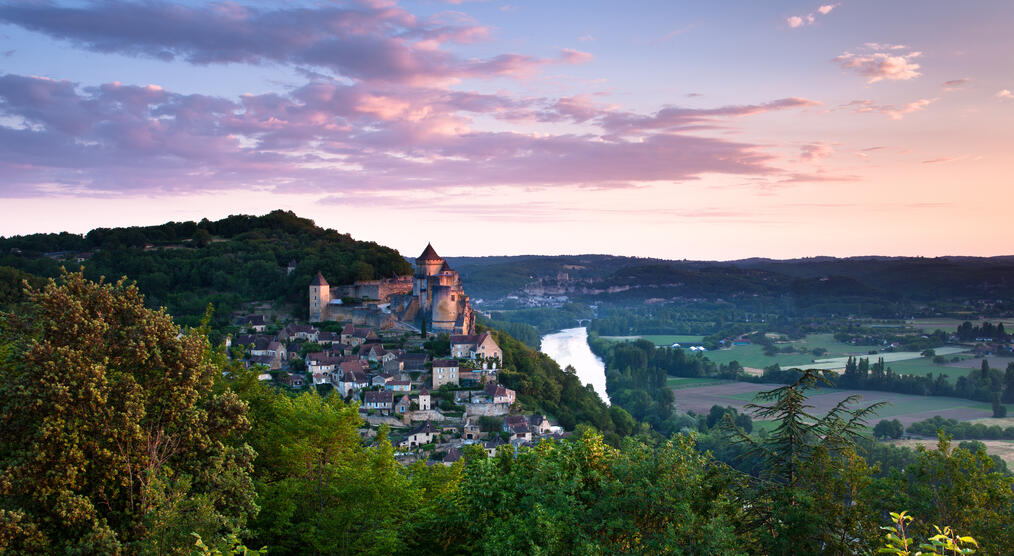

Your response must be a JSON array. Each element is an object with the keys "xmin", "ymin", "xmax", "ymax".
[{"xmin": 724, "ymin": 369, "xmax": 883, "ymax": 554}]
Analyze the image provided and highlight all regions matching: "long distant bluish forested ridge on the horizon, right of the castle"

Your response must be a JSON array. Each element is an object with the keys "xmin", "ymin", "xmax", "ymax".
[{"xmin": 449, "ymin": 255, "xmax": 1014, "ymax": 302}]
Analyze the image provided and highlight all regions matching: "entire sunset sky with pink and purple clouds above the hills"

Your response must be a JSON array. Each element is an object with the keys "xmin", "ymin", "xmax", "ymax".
[{"xmin": 0, "ymin": 0, "xmax": 1014, "ymax": 260}]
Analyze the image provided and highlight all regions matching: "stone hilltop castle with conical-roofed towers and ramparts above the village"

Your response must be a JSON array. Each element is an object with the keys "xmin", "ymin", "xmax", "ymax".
[{"xmin": 309, "ymin": 244, "xmax": 476, "ymax": 334}]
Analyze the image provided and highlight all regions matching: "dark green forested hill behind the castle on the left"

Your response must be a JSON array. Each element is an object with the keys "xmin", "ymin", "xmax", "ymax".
[{"xmin": 0, "ymin": 210, "xmax": 412, "ymax": 324}]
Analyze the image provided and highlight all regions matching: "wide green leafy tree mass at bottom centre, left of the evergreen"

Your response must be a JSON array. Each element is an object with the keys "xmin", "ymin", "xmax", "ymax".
[{"xmin": 433, "ymin": 430, "xmax": 739, "ymax": 555}]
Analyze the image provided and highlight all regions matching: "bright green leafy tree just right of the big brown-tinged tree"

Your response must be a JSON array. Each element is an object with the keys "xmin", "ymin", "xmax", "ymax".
[{"xmin": 241, "ymin": 376, "xmax": 421, "ymax": 554}]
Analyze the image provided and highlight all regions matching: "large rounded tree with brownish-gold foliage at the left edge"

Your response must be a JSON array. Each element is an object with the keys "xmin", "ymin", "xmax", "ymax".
[{"xmin": 0, "ymin": 273, "xmax": 257, "ymax": 553}]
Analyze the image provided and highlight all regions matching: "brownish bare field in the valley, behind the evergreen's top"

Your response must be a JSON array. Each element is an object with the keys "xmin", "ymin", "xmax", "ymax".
[{"xmin": 673, "ymin": 381, "xmax": 1014, "ymax": 426}]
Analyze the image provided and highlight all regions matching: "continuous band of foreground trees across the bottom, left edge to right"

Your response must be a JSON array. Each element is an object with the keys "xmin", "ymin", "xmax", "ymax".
[{"xmin": 0, "ymin": 275, "xmax": 1014, "ymax": 555}]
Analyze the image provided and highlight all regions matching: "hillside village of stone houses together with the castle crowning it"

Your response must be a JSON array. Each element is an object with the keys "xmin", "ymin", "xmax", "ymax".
[{"xmin": 225, "ymin": 246, "xmax": 565, "ymax": 465}]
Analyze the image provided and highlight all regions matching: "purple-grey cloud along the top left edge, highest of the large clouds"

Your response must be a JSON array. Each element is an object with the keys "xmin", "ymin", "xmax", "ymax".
[{"xmin": 0, "ymin": 2, "xmax": 590, "ymax": 84}]
